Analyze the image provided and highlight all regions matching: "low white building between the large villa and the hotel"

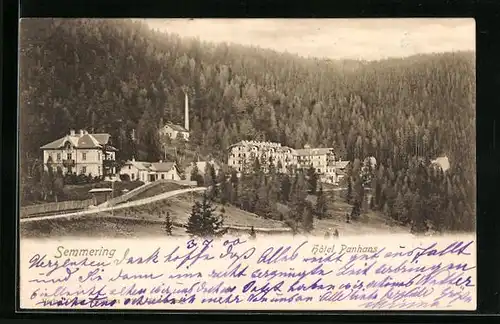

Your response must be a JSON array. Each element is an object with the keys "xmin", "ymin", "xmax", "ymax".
[{"xmin": 120, "ymin": 159, "xmax": 181, "ymax": 183}]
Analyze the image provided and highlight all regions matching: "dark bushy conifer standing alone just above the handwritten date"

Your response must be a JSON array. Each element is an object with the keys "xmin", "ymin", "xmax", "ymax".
[{"xmin": 186, "ymin": 194, "xmax": 227, "ymax": 237}]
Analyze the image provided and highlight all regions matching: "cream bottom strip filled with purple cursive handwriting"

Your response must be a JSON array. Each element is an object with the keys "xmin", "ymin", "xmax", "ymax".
[{"xmin": 21, "ymin": 238, "xmax": 476, "ymax": 310}]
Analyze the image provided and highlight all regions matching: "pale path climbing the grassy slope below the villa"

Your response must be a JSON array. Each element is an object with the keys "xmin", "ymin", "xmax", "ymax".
[{"xmin": 20, "ymin": 187, "xmax": 207, "ymax": 223}]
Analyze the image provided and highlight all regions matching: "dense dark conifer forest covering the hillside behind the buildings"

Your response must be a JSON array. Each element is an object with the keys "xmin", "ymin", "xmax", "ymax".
[{"xmin": 20, "ymin": 19, "xmax": 476, "ymax": 231}]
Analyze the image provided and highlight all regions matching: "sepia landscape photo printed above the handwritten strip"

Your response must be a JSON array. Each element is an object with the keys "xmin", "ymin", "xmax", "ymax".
[{"xmin": 19, "ymin": 18, "xmax": 476, "ymax": 238}]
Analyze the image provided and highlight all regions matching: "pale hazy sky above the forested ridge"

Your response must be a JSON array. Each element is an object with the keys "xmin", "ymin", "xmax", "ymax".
[{"xmin": 144, "ymin": 18, "xmax": 476, "ymax": 60}]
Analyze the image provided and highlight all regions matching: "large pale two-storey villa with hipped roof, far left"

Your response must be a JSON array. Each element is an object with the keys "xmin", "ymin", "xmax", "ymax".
[{"xmin": 40, "ymin": 130, "xmax": 118, "ymax": 177}]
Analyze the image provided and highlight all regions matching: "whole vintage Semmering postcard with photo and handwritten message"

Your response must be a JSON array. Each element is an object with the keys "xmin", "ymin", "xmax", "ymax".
[{"xmin": 16, "ymin": 18, "xmax": 477, "ymax": 311}]
